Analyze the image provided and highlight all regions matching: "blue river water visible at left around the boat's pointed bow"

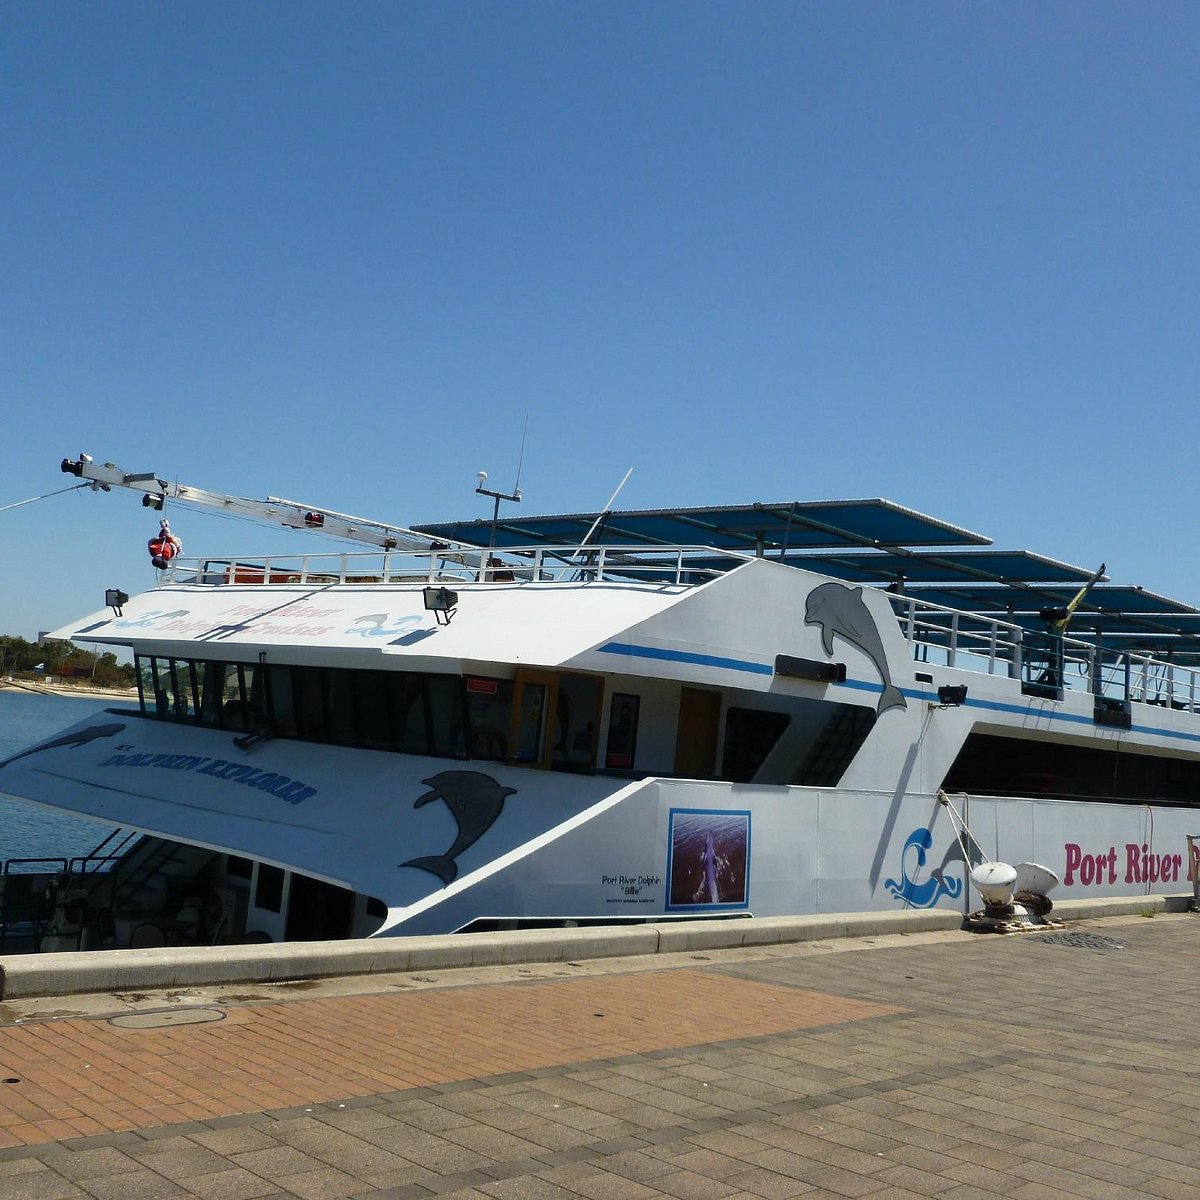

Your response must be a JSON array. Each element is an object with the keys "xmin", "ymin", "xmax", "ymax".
[{"xmin": 0, "ymin": 689, "xmax": 114, "ymax": 864}]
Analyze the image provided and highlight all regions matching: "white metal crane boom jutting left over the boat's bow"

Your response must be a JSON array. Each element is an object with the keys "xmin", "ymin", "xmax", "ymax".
[{"xmin": 62, "ymin": 454, "xmax": 466, "ymax": 552}]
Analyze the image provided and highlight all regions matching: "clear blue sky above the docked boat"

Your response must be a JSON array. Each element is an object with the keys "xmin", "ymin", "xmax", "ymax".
[{"xmin": 0, "ymin": 0, "xmax": 1200, "ymax": 637}]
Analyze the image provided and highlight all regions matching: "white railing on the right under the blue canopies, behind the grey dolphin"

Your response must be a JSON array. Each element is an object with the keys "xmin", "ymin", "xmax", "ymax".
[{"xmin": 888, "ymin": 594, "xmax": 1200, "ymax": 713}]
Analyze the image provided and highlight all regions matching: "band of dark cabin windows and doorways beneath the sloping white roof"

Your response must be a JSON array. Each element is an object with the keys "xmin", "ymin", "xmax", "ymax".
[{"xmin": 137, "ymin": 655, "xmax": 790, "ymax": 782}]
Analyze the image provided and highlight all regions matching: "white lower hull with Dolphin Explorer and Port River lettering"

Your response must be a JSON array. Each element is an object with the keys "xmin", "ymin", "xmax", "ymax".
[{"xmin": 0, "ymin": 709, "xmax": 1198, "ymax": 936}]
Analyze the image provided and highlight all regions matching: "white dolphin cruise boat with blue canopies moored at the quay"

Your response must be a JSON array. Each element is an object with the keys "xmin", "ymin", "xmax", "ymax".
[{"xmin": 0, "ymin": 456, "xmax": 1200, "ymax": 948}]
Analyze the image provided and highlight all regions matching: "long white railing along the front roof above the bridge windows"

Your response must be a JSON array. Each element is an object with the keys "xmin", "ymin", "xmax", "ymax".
[{"xmin": 162, "ymin": 545, "xmax": 750, "ymax": 587}]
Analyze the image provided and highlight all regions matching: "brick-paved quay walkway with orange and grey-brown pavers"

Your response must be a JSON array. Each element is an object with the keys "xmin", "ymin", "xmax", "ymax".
[{"xmin": 0, "ymin": 916, "xmax": 1200, "ymax": 1200}]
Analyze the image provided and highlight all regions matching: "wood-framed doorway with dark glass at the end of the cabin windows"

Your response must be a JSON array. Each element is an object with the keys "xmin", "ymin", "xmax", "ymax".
[{"xmin": 509, "ymin": 667, "xmax": 604, "ymax": 770}]
